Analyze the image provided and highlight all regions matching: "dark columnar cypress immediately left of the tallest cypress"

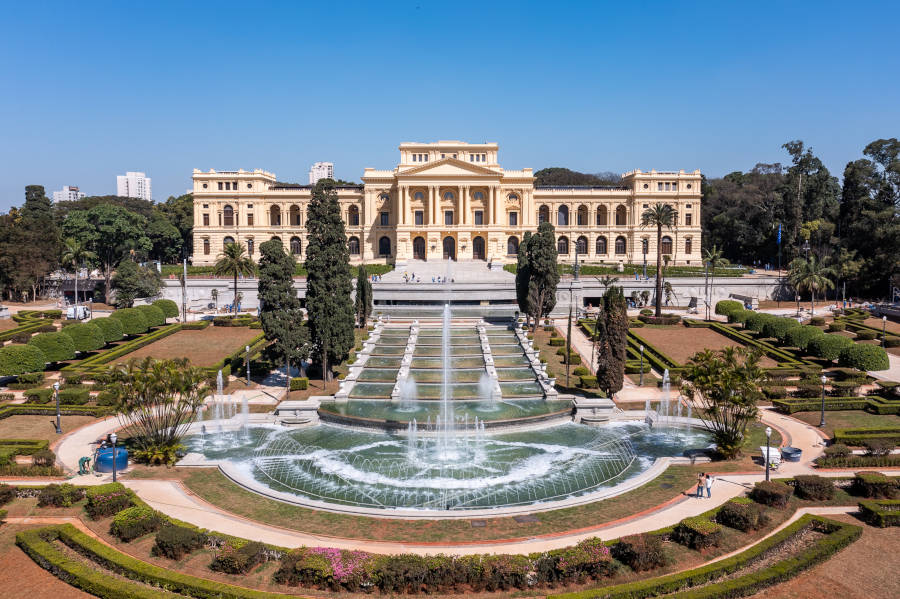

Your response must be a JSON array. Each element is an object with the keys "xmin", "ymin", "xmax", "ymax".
[{"xmin": 258, "ymin": 239, "xmax": 309, "ymax": 393}]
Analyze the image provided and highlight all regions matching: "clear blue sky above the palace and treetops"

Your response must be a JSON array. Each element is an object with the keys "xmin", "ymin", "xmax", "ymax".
[{"xmin": 0, "ymin": 0, "xmax": 900, "ymax": 210}]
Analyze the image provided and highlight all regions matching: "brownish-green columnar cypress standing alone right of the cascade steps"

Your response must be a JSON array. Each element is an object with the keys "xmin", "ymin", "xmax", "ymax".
[{"xmin": 596, "ymin": 285, "xmax": 628, "ymax": 397}]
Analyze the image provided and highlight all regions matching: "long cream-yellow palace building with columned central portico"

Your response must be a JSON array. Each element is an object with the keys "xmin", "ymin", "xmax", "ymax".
[{"xmin": 193, "ymin": 141, "xmax": 701, "ymax": 265}]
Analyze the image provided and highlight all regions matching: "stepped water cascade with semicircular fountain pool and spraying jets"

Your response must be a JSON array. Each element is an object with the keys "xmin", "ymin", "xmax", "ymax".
[{"xmin": 187, "ymin": 262, "xmax": 709, "ymax": 517}]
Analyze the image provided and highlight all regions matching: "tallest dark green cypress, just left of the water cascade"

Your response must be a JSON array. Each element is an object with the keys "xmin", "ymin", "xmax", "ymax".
[{"xmin": 304, "ymin": 179, "xmax": 353, "ymax": 383}]
